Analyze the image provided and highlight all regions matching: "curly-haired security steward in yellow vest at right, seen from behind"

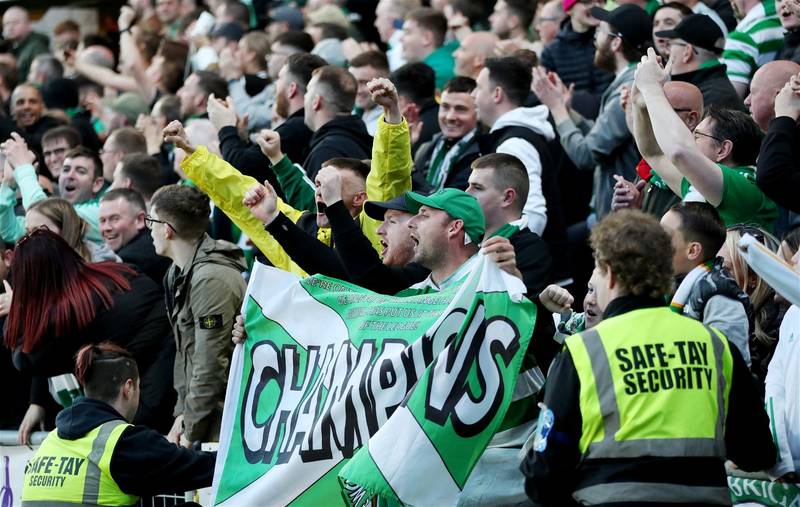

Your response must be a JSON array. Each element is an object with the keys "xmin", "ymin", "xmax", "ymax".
[{"xmin": 522, "ymin": 211, "xmax": 775, "ymax": 507}]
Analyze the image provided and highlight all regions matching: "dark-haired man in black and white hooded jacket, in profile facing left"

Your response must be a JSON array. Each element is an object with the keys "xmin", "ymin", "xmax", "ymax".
[{"xmin": 473, "ymin": 57, "xmax": 555, "ymax": 235}]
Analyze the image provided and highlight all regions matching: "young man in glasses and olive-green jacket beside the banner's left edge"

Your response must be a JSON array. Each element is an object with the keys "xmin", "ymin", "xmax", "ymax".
[{"xmin": 145, "ymin": 185, "xmax": 247, "ymax": 447}]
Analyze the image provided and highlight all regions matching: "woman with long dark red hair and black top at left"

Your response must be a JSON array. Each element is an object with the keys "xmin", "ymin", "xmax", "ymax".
[{"xmin": 5, "ymin": 227, "xmax": 175, "ymax": 442}]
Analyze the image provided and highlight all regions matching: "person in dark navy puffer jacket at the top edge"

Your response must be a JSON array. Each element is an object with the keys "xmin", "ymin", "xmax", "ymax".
[{"xmin": 541, "ymin": 0, "xmax": 614, "ymax": 118}]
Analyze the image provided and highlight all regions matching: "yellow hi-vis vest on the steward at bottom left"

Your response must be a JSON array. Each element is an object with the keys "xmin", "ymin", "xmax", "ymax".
[{"xmin": 22, "ymin": 420, "xmax": 139, "ymax": 507}]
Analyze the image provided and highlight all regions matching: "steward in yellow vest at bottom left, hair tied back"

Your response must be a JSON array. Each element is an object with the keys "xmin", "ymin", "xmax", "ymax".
[{"xmin": 22, "ymin": 342, "xmax": 216, "ymax": 506}]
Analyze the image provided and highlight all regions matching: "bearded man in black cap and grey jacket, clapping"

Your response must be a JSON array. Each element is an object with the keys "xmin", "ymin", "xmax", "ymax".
[{"xmin": 533, "ymin": 4, "xmax": 652, "ymax": 223}]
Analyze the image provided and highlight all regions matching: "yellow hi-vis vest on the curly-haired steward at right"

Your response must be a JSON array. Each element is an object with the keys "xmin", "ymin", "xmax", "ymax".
[{"xmin": 566, "ymin": 307, "xmax": 733, "ymax": 505}]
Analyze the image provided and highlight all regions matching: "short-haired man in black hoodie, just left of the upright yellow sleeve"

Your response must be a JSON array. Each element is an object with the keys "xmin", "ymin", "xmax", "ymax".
[{"xmin": 303, "ymin": 65, "xmax": 372, "ymax": 181}]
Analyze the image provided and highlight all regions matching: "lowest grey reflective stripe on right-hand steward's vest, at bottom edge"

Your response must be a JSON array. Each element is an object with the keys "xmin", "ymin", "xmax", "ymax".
[{"xmin": 573, "ymin": 482, "xmax": 731, "ymax": 505}]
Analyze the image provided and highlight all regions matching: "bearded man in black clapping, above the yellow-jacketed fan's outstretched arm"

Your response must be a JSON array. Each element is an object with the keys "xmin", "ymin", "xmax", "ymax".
[{"xmin": 208, "ymin": 53, "xmax": 326, "ymax": 181}]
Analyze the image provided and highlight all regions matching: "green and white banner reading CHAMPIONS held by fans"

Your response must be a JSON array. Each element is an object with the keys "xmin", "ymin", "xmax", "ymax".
[{"xmin": 213, "ymin": 254, "xmax": 538, "ymax": 506}]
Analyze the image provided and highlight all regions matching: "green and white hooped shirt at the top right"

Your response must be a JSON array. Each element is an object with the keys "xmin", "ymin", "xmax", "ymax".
[{"xmin": 722, "ymin": 0, "xmax": 783, "ymax": 85}]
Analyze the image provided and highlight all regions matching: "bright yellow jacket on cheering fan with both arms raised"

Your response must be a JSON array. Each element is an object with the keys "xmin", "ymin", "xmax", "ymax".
[{"xmin": 181, "ymin": 116, "xmax": 413, "ymax": 276}]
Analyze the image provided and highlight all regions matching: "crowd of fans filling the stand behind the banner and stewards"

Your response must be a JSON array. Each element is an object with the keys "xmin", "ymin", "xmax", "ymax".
[{"xmin": 0, "ymin": 0, "xmax": 800, "ymax": 499}]
